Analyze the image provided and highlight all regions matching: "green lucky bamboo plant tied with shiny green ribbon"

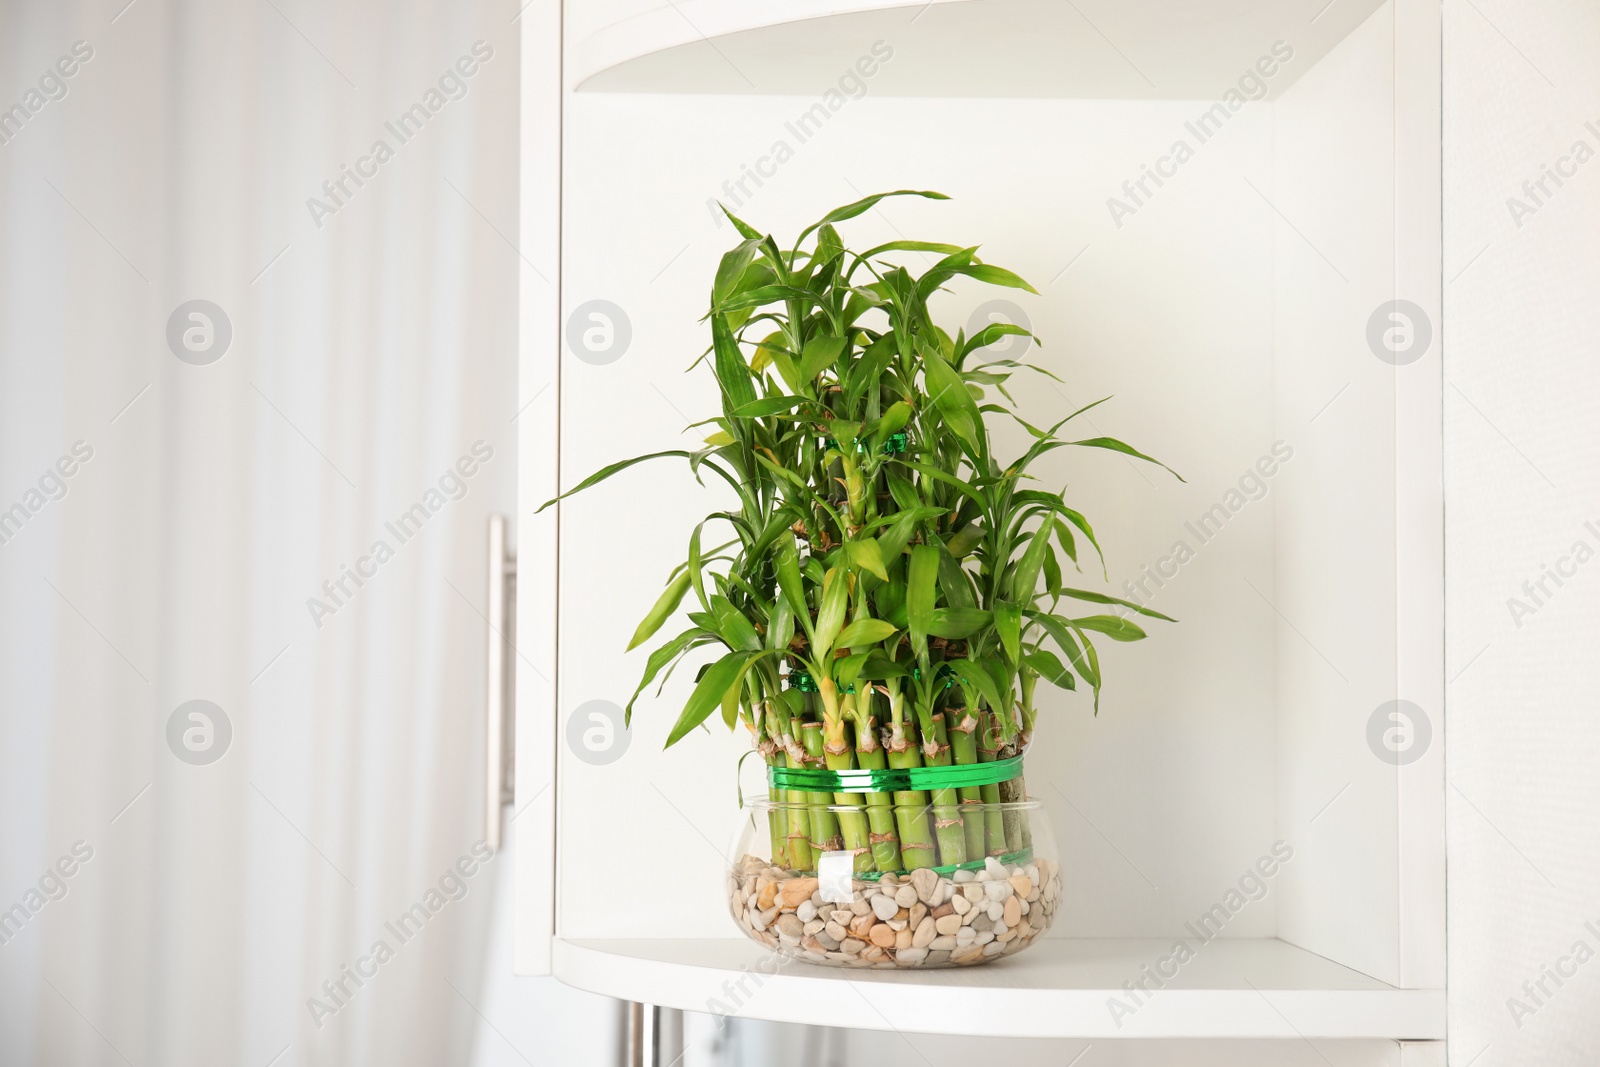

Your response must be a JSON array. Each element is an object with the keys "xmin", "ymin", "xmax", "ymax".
[{"xmin": 546, "ymin": 190, "xmax": 1176, "ymax": 872}]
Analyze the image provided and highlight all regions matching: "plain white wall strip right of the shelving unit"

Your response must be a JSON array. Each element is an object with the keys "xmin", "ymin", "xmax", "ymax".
[{"xmin": 1445, "ymin": 0, "xmax": 1600, "ymax": 1067}]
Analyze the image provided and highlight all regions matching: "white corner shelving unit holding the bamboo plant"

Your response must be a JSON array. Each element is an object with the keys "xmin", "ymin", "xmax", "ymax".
[{"xmin": 512, "ymin": 0, "xmax": 1445, "ymax": 1043}]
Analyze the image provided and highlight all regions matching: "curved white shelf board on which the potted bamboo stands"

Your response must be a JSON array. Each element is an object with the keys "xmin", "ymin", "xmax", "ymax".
[{"xmin": 554, "ymin": 937, "xmax": 1445, "ymax": 1040}]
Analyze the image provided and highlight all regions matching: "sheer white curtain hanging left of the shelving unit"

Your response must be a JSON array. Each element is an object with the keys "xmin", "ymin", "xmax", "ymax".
[{"xmin": 0, "ymin": 0, "xmax": 531, "ymax": 1067}]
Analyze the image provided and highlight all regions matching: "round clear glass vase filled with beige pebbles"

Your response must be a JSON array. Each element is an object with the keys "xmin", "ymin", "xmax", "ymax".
[{"xmin": 726, "ymin": 795, "xmax": 1061, "ymax": 969}]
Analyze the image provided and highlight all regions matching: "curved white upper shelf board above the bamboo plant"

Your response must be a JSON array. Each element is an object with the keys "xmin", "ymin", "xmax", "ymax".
[{"xmin": 568, "ymin": 0, "xmax": 1379, "ymax": 101}]
